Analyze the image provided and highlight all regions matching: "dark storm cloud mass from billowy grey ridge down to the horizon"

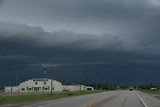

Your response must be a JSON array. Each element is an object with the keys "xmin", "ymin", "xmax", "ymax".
[{"xmin": 0, "ymin": 22, "xmax": 160, "ymax": 86}]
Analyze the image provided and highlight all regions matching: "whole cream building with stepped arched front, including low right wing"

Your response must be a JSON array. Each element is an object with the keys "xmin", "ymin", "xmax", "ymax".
[{"xmin": 5, "ymin": 78, "xmax": 94, "ymax": 93}]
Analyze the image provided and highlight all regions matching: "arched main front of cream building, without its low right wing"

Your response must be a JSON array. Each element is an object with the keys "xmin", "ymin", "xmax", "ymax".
[{"xmin": 5, "ymin": 78, "xmax": 62, "ymax": 92}]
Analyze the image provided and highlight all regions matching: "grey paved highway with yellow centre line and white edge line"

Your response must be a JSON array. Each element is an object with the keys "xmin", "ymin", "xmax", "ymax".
[{"xmin": 22, "ymin": 91, "xmax": 160, "ymax": 107}]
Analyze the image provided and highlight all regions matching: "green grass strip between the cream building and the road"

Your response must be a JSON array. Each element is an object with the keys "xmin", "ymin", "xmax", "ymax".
[{"xmin": 0, "ymin": 91, "xmax": 97, "ymax": 105}]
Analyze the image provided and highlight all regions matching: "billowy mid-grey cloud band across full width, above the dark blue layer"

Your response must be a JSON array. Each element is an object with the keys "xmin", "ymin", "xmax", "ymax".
[{"xmin": 0, "ymin": 22, "xmax": 160, "ymax": 54}]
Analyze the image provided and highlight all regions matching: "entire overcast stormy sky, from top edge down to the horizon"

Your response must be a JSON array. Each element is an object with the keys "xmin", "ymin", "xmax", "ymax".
[{"xmin": 0, "ymin": 0, "xmax": 160, "ymax": 86}]
